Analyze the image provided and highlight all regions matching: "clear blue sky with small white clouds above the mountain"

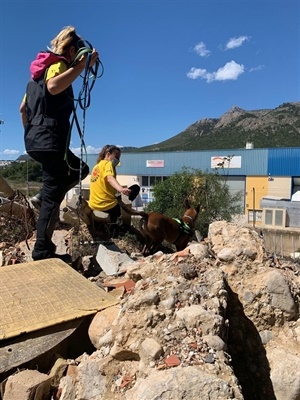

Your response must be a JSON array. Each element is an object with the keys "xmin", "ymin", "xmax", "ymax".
[{"xmin": 0, "ymin": 0, "xmax": 300, "ymax": 160}]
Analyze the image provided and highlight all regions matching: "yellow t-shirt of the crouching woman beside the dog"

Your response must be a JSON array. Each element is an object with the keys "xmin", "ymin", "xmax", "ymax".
[{"xmin": 88, "ymin": 160, "xmax": 118, "ymax": 211}]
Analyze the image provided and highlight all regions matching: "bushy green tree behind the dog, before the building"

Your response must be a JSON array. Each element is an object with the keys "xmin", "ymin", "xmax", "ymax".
[{"xmin": 146, "ymin": 168, "xmax": 242, "ymax": 237}]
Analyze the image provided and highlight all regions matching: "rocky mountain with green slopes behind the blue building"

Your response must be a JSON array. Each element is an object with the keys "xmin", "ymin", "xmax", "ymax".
[{"xmin": 134, "ymin": 102, "xmax": 300, "ymax": 151}]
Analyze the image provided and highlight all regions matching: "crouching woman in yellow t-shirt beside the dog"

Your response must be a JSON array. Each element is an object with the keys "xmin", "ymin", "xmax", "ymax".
[{"xmin": 88, "ymin": 145, "xmax": 131, "ymax": 223}]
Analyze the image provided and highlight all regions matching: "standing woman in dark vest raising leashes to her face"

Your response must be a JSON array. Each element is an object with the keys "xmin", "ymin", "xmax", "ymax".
[{"xmin": 20, "ymin": 26, "xmax": 98, "ymax": 261}]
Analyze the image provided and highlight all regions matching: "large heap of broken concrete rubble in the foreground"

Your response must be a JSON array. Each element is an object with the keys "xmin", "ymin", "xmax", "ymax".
[{"xmin": 1, "ymin": 221, "xmax": 300, "ymax": 400}]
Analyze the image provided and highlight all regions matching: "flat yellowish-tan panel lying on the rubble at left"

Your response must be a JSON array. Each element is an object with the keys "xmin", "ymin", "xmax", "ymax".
[{"xmin": 0, "ymin": 258, "xmax": 117, "ymax": 340}]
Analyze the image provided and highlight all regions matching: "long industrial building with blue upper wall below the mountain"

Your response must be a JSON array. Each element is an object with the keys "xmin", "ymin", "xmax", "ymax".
[{"xmin": 82, "ymin": 147, "xmax": 300, "ymax": 227}]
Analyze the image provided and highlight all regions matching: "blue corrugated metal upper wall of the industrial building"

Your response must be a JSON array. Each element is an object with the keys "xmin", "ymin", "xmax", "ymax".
[{"xmin": 87, "ymin": 147, "xmax": 300, "ymax": 176}]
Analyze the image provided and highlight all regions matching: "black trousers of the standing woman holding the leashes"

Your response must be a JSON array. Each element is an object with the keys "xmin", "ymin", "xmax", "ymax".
[{"xmin": 28, "ymin": 150, "xmax": 89, "ymax": 260}]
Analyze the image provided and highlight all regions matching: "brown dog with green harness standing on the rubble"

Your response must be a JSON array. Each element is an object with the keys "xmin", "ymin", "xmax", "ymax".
[{"xmin": 120, "ymin": 200, "xmax": 200, "ymax": 256}]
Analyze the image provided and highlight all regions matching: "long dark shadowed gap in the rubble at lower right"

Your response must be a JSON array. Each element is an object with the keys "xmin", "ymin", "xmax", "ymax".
[{"xmin": 227, "ymin": 286, "xmax": 276, "ymax": 400}]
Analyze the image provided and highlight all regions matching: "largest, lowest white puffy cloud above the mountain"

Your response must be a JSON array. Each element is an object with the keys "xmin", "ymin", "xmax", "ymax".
[{"xmin": 186, "ymin": 61, "xmax": 245, "ymax": 83}]
